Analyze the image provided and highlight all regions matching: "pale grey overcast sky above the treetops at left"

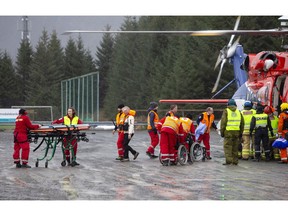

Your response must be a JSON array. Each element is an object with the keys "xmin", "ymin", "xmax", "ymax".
[{"xmin": 0, "ymin": 16, "xmax": 124, "ymax": 61}]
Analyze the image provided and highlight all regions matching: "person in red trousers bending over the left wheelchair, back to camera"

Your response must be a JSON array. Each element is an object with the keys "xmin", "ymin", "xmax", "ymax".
[{"xmin": 160, "ymin": 116, "xmax": 184, "ymax": 166}]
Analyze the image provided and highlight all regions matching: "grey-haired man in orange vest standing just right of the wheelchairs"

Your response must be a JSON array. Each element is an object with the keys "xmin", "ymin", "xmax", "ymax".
[{"xmin": 197, "ymin": 107, "xmax": 217, "ymax": 160}]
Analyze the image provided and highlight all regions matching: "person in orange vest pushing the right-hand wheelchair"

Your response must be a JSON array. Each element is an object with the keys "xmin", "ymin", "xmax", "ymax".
[{"xmin": 180, "ymin": 113, "xmax": 195, "ymax": 163}]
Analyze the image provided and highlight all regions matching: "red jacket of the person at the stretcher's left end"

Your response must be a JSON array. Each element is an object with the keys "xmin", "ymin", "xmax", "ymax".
[{"xmin": 14, "ymin": 115, "xmax": 40, "ymax": 143}]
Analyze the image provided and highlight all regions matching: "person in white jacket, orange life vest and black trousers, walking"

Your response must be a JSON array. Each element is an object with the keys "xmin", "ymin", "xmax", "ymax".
[{"xmin": 121, "ymin": 106, "xmax": 139, "ymax": 162}]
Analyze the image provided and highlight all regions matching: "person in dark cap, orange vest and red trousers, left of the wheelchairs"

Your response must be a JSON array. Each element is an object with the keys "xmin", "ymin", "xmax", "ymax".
[{"xmin": 146, "ymin": 102, "xmax": 159, "ymax": 159}]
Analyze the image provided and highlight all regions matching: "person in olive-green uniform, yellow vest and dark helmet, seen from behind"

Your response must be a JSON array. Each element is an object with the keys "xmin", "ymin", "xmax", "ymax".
[{"xmin": 220, "ymin": 99, "xmax": 244, "ymax": 165}]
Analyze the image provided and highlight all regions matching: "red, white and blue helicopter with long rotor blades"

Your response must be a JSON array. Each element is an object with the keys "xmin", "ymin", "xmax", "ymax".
[{"xmin": 63, "ymin": 16, "xmax": 288, "ymax": 114}]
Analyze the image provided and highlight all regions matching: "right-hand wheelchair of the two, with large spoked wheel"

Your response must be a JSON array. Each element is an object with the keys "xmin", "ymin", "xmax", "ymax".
[{"xmin": 186, "ymin": 133, "xmax": 206, "ymax": 162}]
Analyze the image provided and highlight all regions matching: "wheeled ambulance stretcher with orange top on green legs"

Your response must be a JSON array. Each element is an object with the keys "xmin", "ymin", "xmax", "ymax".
[{"xmin": 28, "ymin": 124, "xmax": 90, "ymax": 168}]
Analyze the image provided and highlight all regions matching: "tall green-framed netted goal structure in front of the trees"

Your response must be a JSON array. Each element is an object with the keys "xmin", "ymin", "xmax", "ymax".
[{"xmin": 61, "ymin": 72, "xmax": 99, "ymax": 122}]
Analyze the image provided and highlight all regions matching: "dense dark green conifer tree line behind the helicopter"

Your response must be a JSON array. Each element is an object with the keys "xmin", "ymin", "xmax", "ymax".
[{"xmin": 0, "ymin": 16, "xmax": 281, "ymax": 120}]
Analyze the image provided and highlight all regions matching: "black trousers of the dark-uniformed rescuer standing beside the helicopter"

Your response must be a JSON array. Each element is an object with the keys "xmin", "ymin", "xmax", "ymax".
[{"xmin": 255, "ymin": 128, "xmax": 270, "ymax": 159}]
